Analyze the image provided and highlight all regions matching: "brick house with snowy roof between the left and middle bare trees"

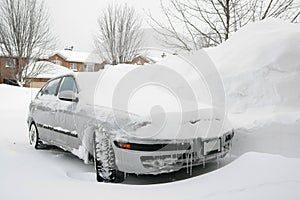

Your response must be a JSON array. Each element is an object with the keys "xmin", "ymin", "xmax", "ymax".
[{"xmin": 48, "ymin": 50, "xmax": 105, "ymax": 72}]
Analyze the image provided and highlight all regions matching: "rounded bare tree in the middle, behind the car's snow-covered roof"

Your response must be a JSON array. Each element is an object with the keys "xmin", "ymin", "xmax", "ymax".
[{"xmin": 95, "ymin": 4, "xmax": 142, "ymax": 65}]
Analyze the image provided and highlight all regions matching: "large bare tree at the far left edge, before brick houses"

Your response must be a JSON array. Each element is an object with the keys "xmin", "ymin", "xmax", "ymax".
[{"xmin": 0, "ymin": 0, "xmax": 53, "ymax": 84}]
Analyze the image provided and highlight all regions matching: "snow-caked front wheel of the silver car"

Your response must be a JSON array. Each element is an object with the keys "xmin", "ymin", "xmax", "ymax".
[{"xmin": 94, "ymin": 131, "xmax": 124, "ymax": 183}]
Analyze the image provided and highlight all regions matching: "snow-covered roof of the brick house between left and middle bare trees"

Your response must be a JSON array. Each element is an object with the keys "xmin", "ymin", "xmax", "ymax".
[{"xmin": 51, "ymin": 50, "xmax": 103, "ymax": 64}]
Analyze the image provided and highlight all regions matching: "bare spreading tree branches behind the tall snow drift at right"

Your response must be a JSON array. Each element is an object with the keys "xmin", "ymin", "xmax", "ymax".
[{"xmin": 148, "ymin": 0, "xmax": 299, "ymax": 50}]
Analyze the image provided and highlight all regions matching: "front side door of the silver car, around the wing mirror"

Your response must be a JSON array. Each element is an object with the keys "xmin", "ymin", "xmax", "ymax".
[{"xmin": 55, "ymin": 76, "xmax": 80, "ymax": 149}]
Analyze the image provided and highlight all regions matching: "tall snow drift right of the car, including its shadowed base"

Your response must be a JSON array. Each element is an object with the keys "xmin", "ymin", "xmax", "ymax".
[{"xmin": 206, "ymin": 19, "xmax": 300, "ymax": 158}]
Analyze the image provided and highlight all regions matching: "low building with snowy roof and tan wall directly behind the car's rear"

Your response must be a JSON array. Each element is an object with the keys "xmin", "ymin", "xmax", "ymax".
[{"xmin": 25, "ymin": 61, "xmax": 73, "ymax": 88}]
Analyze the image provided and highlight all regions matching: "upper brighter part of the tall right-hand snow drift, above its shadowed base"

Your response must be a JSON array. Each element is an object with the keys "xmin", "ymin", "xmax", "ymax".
[{"xmin": 206, "ymin": 19, "xmax": 300, "ymax": 126}]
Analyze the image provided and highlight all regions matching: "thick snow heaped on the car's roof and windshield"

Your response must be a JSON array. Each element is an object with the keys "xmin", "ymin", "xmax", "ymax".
[{"xmin": 75, "ymin": 60, "xmax": 216, "ymax": 117}]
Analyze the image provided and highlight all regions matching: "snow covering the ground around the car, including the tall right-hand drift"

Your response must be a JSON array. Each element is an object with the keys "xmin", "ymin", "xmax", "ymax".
[{"xmin": 0, "ymin": 20, "xmax": 300, "ymax": 200}]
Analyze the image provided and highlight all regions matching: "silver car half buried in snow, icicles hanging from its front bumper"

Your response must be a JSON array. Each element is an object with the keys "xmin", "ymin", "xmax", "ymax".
[{"xmin": 27, "ymin": 68, "xmax": 234, "ymax": 182}]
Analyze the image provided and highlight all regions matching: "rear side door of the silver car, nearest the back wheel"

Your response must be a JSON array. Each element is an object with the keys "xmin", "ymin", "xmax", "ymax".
[{"xmin": 33, "ymin": 78, "xmax": 61, "ymax": 142}]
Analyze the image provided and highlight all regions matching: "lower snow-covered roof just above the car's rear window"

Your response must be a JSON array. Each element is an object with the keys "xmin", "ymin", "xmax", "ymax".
[{"xmin": 27, "ymin": 61, "xmax": 73, "ymax": 78}]
